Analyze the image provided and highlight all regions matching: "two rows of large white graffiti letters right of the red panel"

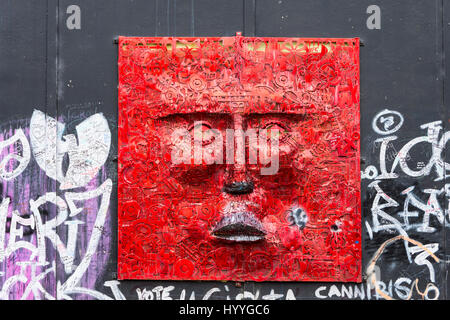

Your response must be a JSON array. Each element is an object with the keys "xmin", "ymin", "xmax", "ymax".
[{"xmin": 361, "ymin": 117, "xmax": 450, "ymax": 242}]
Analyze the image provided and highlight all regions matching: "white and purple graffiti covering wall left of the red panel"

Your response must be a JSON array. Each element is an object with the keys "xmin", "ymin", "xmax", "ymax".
[{"xmin": 0, "ymin": 110, "xmax": 113, "ymax": 299}]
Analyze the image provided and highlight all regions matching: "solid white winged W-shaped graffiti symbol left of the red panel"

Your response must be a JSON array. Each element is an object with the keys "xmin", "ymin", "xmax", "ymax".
[{"xmin": 30, "ymin": 110, "xmax": 111, "ymax": 190}]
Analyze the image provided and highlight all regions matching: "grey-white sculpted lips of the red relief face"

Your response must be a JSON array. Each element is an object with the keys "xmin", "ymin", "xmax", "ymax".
[{"xmin": 211, "ymin": 212, "xmax": 266, "ymax": 242}]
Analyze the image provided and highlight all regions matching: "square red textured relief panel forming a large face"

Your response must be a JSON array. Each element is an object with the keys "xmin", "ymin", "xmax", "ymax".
[{"xmin": 118, "ymin": 35, "xmax": 361, "ymax": 281}]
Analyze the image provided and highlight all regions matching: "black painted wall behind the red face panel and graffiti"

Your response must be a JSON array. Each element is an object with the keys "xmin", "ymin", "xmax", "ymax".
[{"xmin": 0, "ymin": 0, "xmax": 450, "ymax": 299}]
